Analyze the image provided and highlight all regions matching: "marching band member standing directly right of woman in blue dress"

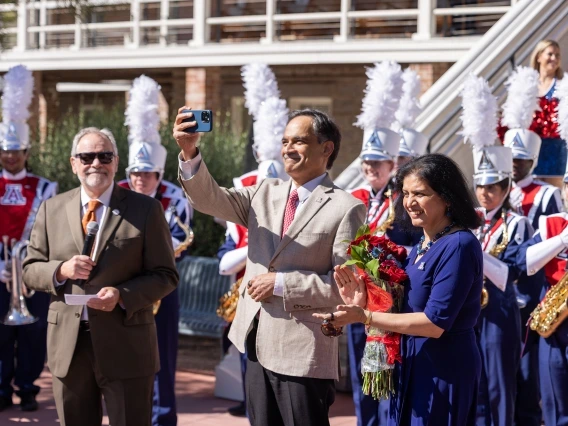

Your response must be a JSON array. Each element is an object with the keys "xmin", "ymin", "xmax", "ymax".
[{"xmin": 462, "ymin": 76, "xmax": 532, "ymax": 426}]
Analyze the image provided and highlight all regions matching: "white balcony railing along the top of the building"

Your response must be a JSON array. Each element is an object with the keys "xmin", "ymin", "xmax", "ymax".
[{"xmin": 0, "ymin": 0, "xmax": 517, "ymax": 52}]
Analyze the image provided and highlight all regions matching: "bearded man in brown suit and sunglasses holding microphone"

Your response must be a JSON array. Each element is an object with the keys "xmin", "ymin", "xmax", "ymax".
[{"xmin": 24, "ymin": 128, "xmax": 178, "ymax": 426}]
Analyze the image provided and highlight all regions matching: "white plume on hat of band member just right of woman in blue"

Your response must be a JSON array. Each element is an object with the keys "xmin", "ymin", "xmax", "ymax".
[{"xmin": 459, "ymin": 74, "xmax": 497, "ymax": 149}]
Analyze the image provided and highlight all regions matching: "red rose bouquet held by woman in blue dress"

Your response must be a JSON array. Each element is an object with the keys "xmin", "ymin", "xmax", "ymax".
[{"xmin": 345, "ymin": 225, "xmax": 408, "ymax": 399}]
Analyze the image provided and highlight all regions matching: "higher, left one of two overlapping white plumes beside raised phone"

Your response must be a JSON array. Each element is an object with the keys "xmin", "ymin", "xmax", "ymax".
[{"xmin": 241, "ymin": 63, "xmax": 280, "ymax": 120}]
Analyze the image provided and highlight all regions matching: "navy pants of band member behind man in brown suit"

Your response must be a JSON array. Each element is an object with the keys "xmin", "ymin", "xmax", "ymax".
[{"xmin": 152, "ymin": 288, "xmax": 179, "ymax": 426}]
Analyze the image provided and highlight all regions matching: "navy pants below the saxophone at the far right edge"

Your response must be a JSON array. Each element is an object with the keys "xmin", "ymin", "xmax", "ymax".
[{"xmin": 538, "ymin": 320, "xmax": 568, "ymax": 426}]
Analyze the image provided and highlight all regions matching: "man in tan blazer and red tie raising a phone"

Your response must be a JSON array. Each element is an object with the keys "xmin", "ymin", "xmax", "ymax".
[{"xmin": 174, "ymin": 109, "xmax": 365, "ymax": 426}]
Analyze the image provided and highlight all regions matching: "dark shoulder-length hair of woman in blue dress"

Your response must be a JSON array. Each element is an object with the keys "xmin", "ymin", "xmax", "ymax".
[{"xmin": 394, "ymin": 154, "xmax": 481, "ymax": 229}]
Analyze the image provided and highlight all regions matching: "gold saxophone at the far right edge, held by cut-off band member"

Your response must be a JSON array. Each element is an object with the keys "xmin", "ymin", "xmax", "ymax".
[{"xmin": 529, "ymin": 263, "xmax": 568, "ymax": 337}]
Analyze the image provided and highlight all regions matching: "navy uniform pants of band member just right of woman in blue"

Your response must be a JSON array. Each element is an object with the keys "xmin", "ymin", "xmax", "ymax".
[{"xmin": 477, "ymin": 282, "xmax": 521, "ymax": 426}]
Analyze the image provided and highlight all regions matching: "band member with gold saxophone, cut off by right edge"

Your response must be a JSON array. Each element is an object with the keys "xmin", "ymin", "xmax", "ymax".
[{"xmin": 518, "ymin": 75, "xmax": 568, "ymax": 425}]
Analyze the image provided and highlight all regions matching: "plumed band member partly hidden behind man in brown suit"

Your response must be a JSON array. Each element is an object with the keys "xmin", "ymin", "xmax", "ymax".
[{"xmin": 119, "ymin": 75, "xmax": 192, "ymax": 426}]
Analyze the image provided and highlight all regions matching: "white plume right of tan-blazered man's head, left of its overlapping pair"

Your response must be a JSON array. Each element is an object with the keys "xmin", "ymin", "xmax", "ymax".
[{"xmin": 355, "ymin": 61, "xmax": 404, "ymax": 129}]
